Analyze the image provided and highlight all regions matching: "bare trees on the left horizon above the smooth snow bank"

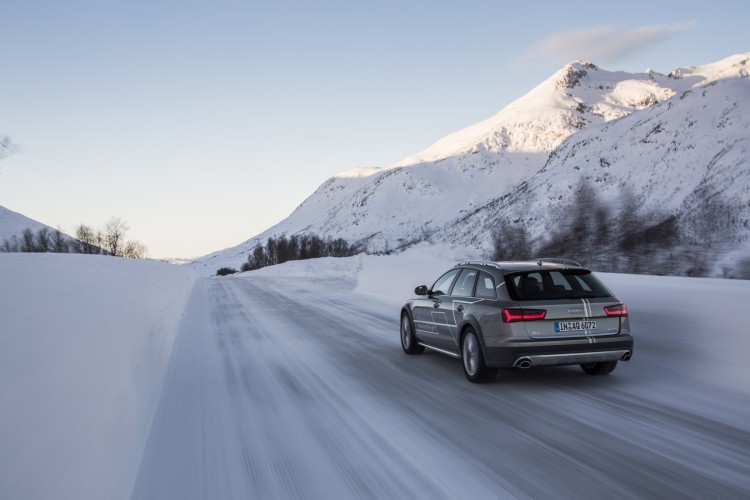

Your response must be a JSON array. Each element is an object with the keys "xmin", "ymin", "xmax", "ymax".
[{"xmin": 0, "ymin": 217, "xmax": 147, "ymax": 259}]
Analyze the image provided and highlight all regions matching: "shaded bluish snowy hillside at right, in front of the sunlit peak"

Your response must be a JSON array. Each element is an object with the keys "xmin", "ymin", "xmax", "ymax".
[{"xmin": 435, "ymin": 58, "xmax": 750, "ymax": 276}]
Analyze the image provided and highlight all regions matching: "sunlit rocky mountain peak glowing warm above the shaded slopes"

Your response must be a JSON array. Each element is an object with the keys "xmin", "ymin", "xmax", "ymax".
[{"xmin": 394, "ymin": 61, "xmax": 688, "ymax": 167}]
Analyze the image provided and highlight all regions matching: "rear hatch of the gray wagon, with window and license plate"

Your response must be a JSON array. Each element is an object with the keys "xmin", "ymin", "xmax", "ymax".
[{"xmin": 504, "ymin": 268, "xmax": 627, "ymax": 339}]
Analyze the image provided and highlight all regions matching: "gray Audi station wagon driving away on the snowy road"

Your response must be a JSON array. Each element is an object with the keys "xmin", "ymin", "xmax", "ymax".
[{"xmin": 401, "ymin": 259, "xmax": 633, "ymax": 382}]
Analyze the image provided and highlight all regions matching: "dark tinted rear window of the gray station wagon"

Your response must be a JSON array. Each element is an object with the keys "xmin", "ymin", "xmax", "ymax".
[{"xmin": 505, "ymin": 269, "xmax": 612, "ymax": 301}]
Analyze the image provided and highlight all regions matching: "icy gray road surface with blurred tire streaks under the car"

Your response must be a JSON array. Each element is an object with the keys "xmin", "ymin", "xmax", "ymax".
[{"xmin": 133, "ymin": 277, "xmax": 750, "ymax": 499}]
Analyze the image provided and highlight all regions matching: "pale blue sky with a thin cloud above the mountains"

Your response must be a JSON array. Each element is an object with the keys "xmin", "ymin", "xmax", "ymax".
[{"xmin": 0, "ymin": 0, "xmax": 750, "ymax": 258}]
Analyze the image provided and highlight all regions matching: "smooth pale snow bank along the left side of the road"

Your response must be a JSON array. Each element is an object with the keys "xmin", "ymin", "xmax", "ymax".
[{"xmin": 0, "ymin": 254, "xmax": 196, "ymax": 499}]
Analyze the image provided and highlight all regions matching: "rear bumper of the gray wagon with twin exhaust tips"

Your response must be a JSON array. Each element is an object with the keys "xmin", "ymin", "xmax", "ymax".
[{"xmin": 485, "ymin": 334, "xmax": 633, "ymax": 368}]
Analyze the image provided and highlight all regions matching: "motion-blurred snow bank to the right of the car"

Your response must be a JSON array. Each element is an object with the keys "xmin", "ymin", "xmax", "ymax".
[{"xmin": 597, "ymin": 273, "xmax": 750, "ymax": 394}]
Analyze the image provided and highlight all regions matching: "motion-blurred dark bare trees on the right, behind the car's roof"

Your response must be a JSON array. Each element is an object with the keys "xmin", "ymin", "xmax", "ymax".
[{"xmin": 492, "ymin": 183, "xmax": 750, "ymax": 279}]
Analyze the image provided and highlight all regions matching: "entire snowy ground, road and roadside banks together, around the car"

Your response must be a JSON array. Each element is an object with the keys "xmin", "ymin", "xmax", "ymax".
[{"xmin": 0, "ymin": 246, "xmax": 750, "ymax": 499}]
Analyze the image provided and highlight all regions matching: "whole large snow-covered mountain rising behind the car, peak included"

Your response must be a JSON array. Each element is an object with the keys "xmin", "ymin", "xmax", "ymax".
[{"xmin": 196, "ymin": 53, "xmax": 750, "ymax": 278}]
